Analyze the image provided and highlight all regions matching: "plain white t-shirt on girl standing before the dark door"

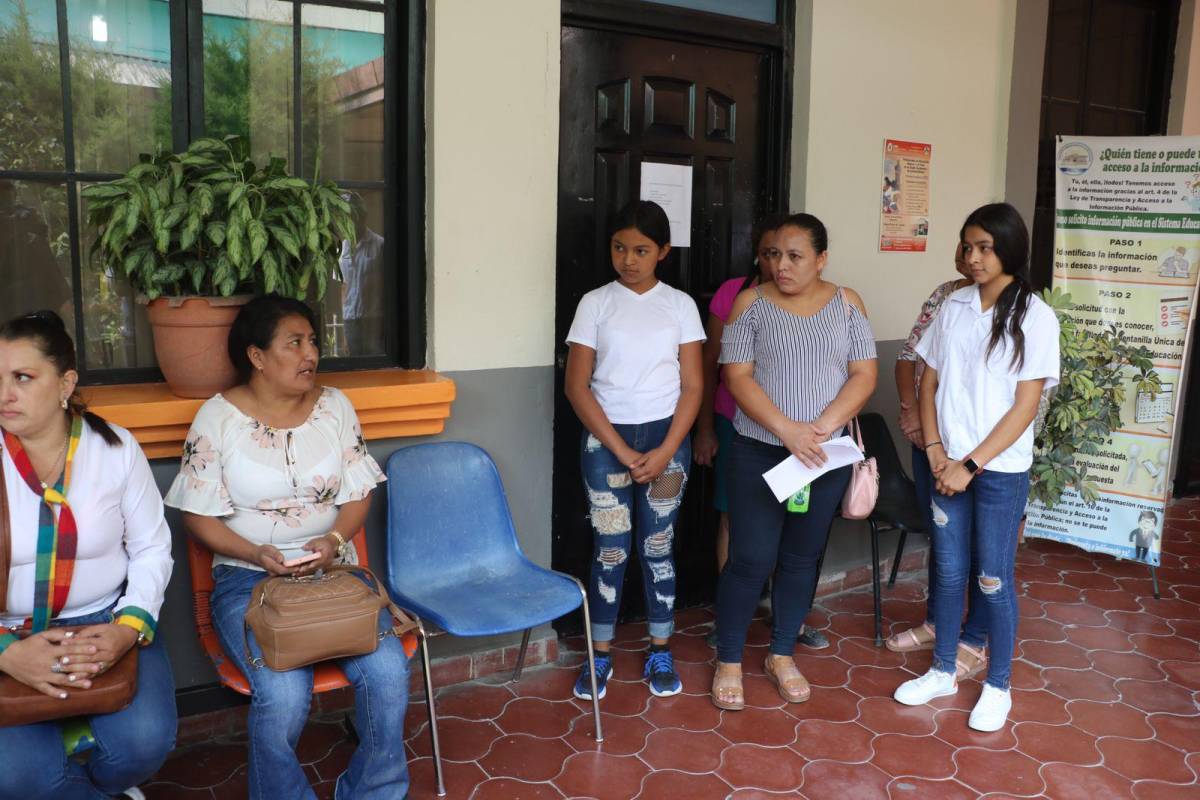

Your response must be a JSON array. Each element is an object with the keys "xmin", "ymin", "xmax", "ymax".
[{"xmin": 566, "ymin": 281, "xmax": 706, "ymax": 425}]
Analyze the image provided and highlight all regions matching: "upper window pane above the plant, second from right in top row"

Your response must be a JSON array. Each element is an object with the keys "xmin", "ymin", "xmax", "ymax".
[{"xmin": 204, "ymin": 0, "xmax": 294, "ymax": 162}]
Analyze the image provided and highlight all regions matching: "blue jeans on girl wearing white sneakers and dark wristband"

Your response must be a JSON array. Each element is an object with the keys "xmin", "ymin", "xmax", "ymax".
[{"xmin": 930, "ymin": 470, "xmax": 1030, "ymax": 690}]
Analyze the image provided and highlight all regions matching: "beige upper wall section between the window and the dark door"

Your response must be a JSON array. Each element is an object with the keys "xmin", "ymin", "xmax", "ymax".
[{"xmin": 426, "ymin": 0, "xmax": 559, "ymax": 371}]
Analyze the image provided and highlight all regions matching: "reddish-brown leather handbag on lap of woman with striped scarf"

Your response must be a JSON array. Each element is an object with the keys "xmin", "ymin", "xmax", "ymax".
[{"xmin": 0, "ymin": 455, "xmax": 138, "ymax": 728}]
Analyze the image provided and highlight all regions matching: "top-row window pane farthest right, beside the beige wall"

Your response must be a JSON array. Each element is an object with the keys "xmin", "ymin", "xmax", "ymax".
[{"xmin": 300, "ymin": 5, "xmax": 384, "ymax": 180}]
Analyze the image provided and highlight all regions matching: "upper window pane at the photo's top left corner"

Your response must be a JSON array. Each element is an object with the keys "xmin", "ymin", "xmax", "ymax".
[{"xmin": 0, "ymin": 0, "xmax": 65, "ymax": 170}]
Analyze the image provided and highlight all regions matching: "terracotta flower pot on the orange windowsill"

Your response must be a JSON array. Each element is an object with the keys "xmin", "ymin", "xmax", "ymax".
[{"xmin": 146, "ymin": 295, "xmax": 252, "ymax": 398}]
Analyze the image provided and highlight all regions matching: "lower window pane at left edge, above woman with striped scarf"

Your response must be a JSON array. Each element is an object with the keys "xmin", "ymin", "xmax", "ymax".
[{"xmin": 0, "ymin": 181, "xmax": 74, "ymax": 332}]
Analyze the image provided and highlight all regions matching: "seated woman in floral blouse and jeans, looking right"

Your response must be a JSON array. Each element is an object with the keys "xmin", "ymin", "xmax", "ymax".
[{"xmin": 167, "ymin": 295, "xmax": 408, "ymax": 800}]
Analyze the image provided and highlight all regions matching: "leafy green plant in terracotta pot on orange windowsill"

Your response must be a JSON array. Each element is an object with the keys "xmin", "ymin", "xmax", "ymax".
[{"xmin": 82, "ymin": 137, "xmax": 354, "ymax": 397}]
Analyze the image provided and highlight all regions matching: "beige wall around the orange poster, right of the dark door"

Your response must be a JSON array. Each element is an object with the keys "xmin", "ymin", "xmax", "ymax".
[{"xmin": 792, "ymin": 0, "xmax": 1016, "ymax": 339}]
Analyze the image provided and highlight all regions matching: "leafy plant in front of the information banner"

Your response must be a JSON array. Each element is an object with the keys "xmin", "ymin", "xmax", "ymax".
[{"xmin": 1030, "ymin": 288, "xmax": 1162, "ymax": 507}]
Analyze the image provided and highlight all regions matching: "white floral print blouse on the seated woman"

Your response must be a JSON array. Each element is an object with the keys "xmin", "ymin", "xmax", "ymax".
[{"xmin": 166, "ymin": 386, "xmax": 385, "ymax": 570}]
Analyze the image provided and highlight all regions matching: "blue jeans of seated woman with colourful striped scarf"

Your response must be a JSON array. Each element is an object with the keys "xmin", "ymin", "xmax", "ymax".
[{"xmin": 0, "ymin": 609, "xmax": 176, "ymax": 800}]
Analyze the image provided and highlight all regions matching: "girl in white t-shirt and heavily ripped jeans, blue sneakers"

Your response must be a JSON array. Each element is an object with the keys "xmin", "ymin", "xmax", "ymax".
[{"xmin": 566, "ymin": 200, "xmax": 704, "ymax": 699}]
